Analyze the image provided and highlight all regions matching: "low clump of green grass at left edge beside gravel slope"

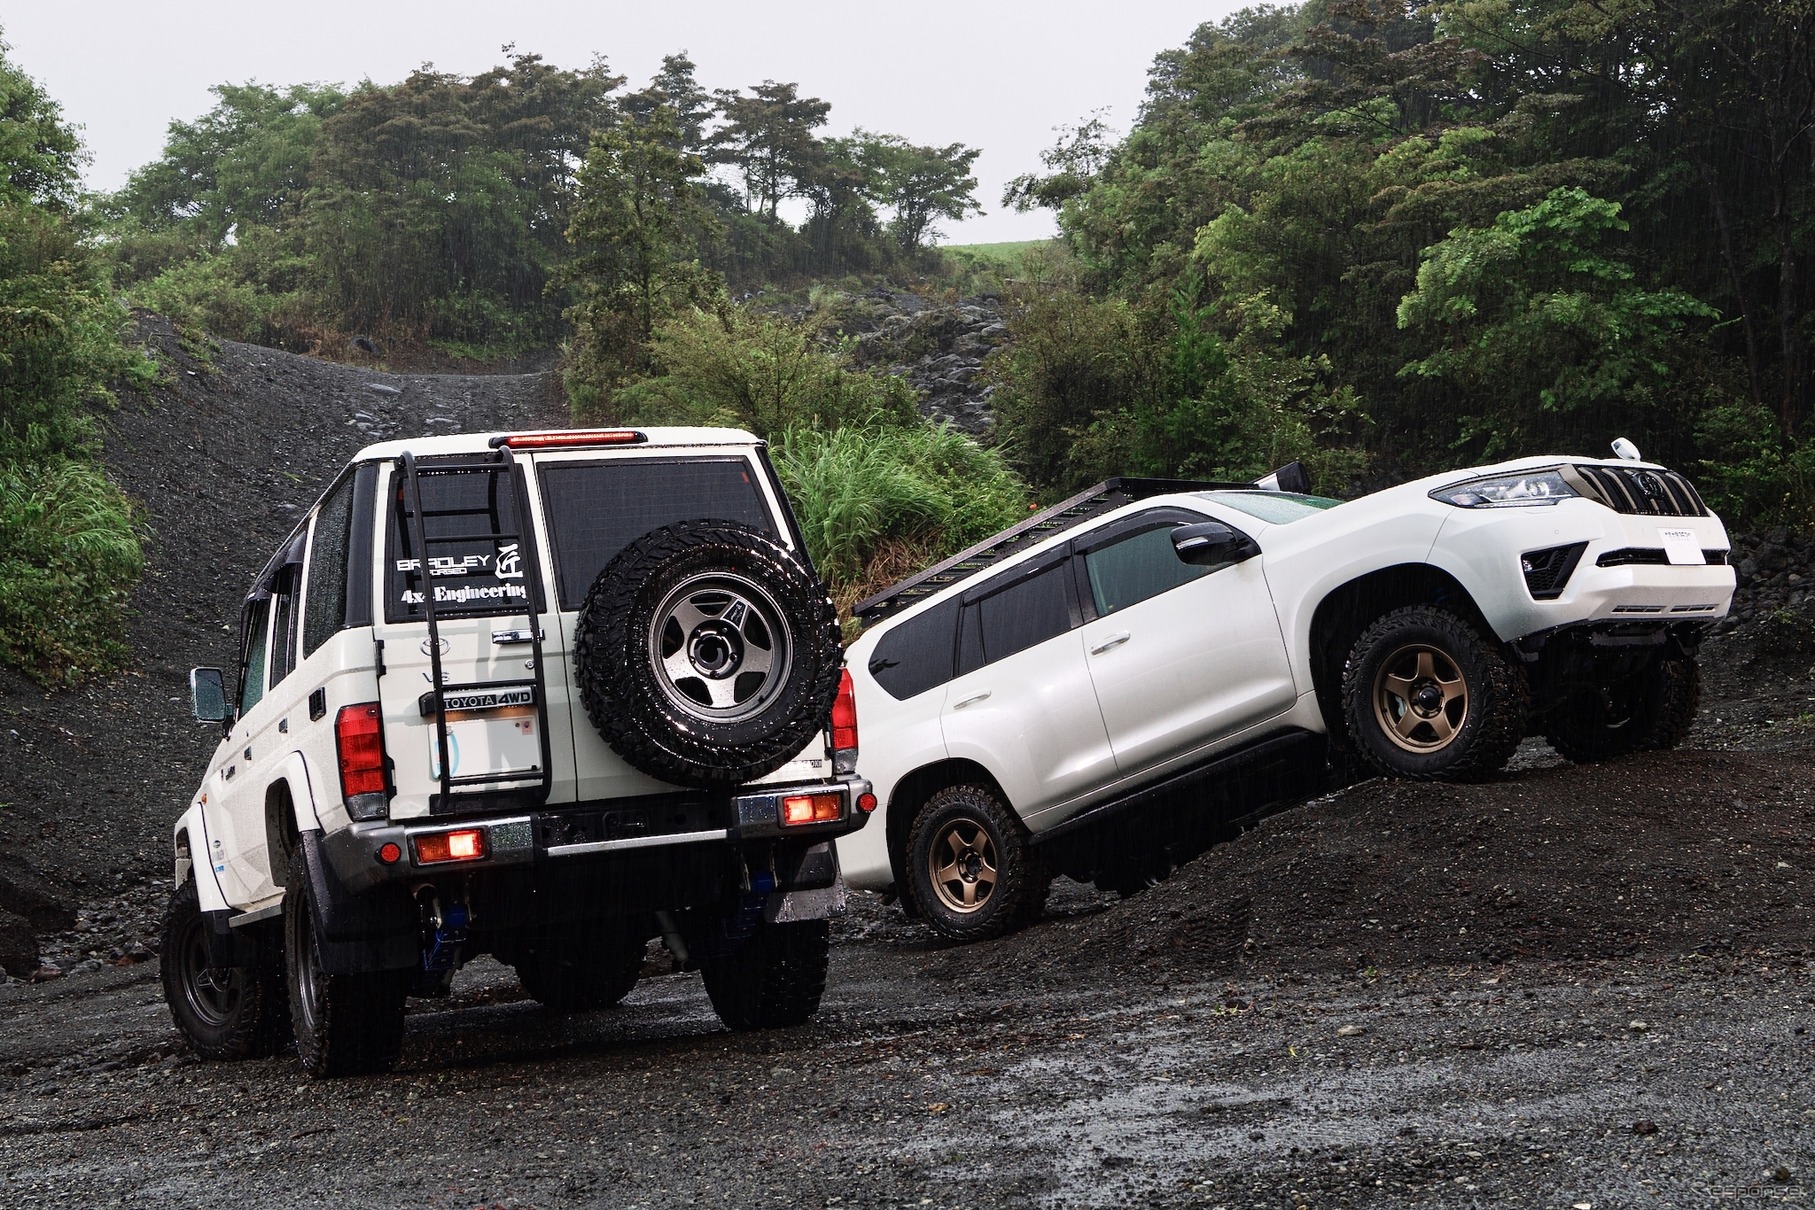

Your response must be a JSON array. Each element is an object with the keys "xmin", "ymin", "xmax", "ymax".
[{"xmin": 0, "ymin": 459, "xmax": 145, "ymax": 682}]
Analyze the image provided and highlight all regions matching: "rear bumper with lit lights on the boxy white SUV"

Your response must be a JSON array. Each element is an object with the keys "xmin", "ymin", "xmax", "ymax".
[{"xmin": 321, "ymin": 778, "xmax": 871, "ymax": 894}]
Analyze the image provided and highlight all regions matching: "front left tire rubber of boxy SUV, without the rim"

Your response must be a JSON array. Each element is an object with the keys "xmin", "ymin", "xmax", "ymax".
[{"xmin": 158, "ymin": 878, "xmax": 290, "ymax": 1061}]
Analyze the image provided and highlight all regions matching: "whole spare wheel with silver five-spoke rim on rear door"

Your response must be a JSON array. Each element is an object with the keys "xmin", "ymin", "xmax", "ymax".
[{"xmin": 574, "ymin": 521, "xmax": 842, "ymax": 787}]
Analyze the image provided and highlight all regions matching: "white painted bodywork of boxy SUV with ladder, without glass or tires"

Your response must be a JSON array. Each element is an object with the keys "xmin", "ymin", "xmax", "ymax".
[{"xmin": 176, "ymin": 428, "xmax": 842, "ymax": 911}]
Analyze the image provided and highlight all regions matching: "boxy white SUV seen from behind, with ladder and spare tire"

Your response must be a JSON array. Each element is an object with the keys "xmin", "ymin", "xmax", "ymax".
[{"xmin": 163, "ymin": 428, "xmax": 875, "ymax": 1076}]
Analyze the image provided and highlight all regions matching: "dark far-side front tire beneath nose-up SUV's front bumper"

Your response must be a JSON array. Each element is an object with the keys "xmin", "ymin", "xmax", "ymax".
[{"xmin": 1545, "ymin": 655, "xmax": 1701, "ymax": 764}]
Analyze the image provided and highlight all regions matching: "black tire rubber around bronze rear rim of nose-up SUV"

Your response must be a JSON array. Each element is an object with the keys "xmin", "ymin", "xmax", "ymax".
[{"xmin": 908, "ymin": 784, "xmax": 1053, "ymax": 942}]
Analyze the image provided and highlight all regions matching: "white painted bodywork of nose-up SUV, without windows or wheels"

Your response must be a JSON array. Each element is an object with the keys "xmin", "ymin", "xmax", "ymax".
[{"xmin": 839, "ymin": 455, "xmax": 1733, "ymax": 889}]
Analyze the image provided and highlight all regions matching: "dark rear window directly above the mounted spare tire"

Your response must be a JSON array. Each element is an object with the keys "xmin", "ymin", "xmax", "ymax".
[{"xmin": 537, "ymin": 457, "xmax": 775, "ymax": 610}]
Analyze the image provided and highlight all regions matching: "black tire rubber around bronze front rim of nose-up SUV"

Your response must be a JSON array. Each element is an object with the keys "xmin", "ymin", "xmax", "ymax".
[{"xmin": 1343, "ymin": 604, "xmax": 1530, "ymax": 782}]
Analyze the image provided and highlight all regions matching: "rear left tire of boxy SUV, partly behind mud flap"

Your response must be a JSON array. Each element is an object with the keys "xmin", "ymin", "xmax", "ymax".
[{"xmin": 283, "ymin": 849, "xmax": 410, "ymax": 1079}]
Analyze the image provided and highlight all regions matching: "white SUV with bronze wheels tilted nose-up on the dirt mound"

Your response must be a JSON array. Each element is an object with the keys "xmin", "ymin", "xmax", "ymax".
[{"xmin": 839, "ymin": 449, "xmax": 1733, "ymax": 940}]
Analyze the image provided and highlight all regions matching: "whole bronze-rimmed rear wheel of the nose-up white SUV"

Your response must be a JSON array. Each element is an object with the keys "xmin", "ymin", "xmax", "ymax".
[{"xmin": 908, "ymin": 784, "xmax": 1053, "ymax": 942}]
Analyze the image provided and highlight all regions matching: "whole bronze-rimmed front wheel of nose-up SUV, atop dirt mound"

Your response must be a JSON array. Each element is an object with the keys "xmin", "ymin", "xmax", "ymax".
[{"xmin": 1343, "ymin": 606, "xmax": 1530, "ymax": 782}]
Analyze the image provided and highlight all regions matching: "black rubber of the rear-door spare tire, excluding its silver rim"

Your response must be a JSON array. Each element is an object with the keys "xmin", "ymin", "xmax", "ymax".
[{"xmin": 574, "ymin": 521, "xmax": 844, "ymax": 789}]
